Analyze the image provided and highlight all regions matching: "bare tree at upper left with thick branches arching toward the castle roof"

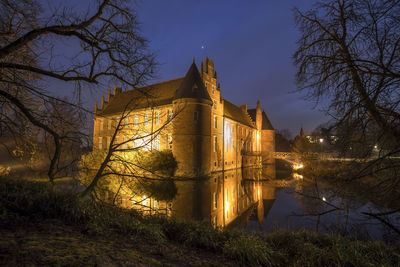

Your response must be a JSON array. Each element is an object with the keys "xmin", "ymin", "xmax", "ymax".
[{"xmin": 0, "ymin": 0, "xmax": 155, "ymax": 181}]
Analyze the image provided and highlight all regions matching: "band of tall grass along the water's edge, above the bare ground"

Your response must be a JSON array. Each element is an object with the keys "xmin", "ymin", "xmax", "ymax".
[{"xmin": 0, "ymin": 178, "xmax": 400, "ymax": 266}]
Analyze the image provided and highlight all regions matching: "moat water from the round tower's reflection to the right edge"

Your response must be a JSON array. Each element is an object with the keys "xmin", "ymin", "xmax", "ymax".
[{"xmin": 168, "ymin": 165, "xmax": 400, "ymax": 242}]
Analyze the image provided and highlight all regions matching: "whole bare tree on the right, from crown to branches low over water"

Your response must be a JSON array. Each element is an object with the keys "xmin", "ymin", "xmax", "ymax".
[{"xmin": 294, "ymin": 0, "xmax": 400, "ymax": 233}]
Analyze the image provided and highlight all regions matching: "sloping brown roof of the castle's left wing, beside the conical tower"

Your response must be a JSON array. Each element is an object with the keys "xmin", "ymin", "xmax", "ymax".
[{"xmin": 97, "ymin": 77, "xmax": 184, "ymax": 116}]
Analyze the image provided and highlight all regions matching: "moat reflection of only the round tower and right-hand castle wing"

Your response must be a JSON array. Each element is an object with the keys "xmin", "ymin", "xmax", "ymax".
[{"xmin": 172, "ymin": 169, "xmax": 260, "ymax": 226}]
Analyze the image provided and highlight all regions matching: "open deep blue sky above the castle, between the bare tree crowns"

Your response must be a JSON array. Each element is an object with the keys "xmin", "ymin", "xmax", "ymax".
[{"xmin": 137, "ymin": 0, "xmax": 328, "ymax": 136}]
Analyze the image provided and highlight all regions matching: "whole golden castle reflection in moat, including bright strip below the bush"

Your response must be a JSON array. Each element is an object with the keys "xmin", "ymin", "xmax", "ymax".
[{"xmin": 111, "ymin": 165, "xmax": 275, "ymax": 227}]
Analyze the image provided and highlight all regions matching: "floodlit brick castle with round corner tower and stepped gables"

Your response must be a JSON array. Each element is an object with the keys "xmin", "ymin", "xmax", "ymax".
[{"xmin": 93, "ymin": 58, "xmax": 275, "ymax": 175}]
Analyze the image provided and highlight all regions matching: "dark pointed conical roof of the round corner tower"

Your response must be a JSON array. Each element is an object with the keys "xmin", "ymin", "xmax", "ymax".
[{"xmin": 174, "ymin": 62, "xmax": 212, "ymax": 101}]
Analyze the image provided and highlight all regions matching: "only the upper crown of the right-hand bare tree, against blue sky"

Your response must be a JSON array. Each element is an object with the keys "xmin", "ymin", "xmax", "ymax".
[{"xmin": 294, "ymin": 0, "xmax": 400, "ymax": 146}]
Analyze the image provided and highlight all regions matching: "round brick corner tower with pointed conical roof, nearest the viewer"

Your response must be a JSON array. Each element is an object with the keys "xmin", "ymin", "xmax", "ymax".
[{"xmin": 172, "ymin": 62, "xmax": 212, "ymax": 175}]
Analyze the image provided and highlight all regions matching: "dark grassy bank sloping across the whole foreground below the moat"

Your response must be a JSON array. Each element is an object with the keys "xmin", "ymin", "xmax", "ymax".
[{"xmin": 0, "ymin": 179, "xmax": 400, "ymax": 266}]
